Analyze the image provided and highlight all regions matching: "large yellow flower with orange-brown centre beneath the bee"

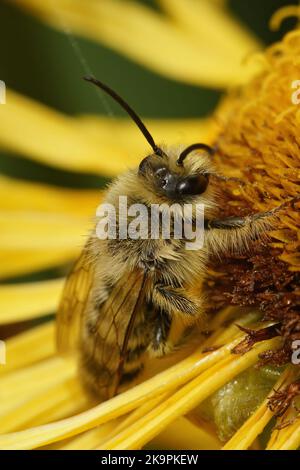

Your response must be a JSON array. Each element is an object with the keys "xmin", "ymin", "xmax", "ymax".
[{"xmin": 0, "ymin": 0, "xmax": 300, "ymax": 449}]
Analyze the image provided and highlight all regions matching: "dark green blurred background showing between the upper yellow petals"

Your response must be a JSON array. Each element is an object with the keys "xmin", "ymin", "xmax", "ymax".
[{"xmin": 0, "ymin": 0, "xmax": 298, "ymax": 187}]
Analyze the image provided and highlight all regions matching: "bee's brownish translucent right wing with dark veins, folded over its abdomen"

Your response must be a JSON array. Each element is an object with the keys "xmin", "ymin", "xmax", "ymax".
[{"xmin": 84, "ymin": 271, "xmax": 145, "ymax": 396}]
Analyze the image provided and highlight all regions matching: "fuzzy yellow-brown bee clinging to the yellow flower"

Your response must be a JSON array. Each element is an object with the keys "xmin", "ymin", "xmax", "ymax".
[{"xmin": 57, "ymin": 77, "xmax": 282, "ymax": 399}]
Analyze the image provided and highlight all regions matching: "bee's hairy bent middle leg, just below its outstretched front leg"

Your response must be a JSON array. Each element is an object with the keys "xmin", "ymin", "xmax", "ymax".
[{"xmin": 153, "ymin": 284, "xmax": 202, "ymax": 317}]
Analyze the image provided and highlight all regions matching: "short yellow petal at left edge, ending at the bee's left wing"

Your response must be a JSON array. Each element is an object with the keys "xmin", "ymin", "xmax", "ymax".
[{"xmin": 0, "ymin": 279, "xmax": 64, "ymax": 324}]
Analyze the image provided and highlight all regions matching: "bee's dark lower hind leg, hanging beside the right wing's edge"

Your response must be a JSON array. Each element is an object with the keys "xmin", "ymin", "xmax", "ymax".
[{"xmin": 148, "ymin": 309, "xmax": 172, "ymax": 357}]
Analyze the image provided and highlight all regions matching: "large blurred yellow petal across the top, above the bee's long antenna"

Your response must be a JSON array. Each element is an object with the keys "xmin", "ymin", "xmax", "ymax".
[{"xmin": 14, "ymin": 0, "xmax": 260, "ymax": 88}]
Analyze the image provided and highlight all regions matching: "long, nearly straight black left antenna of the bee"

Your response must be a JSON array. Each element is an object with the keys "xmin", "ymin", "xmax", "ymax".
[{"xmin": 83, "ymin": 76, "xmax": 164, "ymax": 157}]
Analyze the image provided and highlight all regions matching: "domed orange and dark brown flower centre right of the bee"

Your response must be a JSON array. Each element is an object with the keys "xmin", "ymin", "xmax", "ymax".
[{"xmin": 209, "ymin": 30, "xmax": 300, "ymax": 372}]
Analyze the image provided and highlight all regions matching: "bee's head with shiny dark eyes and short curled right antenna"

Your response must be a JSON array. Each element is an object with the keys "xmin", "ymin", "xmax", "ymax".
[{"xmin": 138, "ymin": 144, "xmax": 212, "ymax": 201}]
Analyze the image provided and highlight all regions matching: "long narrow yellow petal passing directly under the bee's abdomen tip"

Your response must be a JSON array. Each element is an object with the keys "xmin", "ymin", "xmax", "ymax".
[{"xmin": 0, "ymin": 340, "xmax": 240, "ymax": 449}]
